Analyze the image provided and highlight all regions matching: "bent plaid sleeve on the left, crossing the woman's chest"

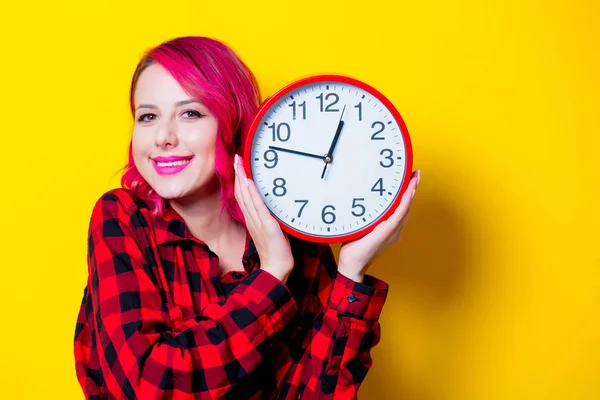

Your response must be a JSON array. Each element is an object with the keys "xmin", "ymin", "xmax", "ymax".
[{"xmin": 88, "ymin": 192, "xmax": 296, "ymax": 399}]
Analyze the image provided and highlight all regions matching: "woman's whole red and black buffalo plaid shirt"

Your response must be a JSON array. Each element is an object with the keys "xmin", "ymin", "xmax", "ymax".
[{"xmin": 75, "ymin": 189, "xmax": 388, "ymax": 399}]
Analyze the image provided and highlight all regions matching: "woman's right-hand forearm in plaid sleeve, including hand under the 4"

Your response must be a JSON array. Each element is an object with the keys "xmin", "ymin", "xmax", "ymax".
[{"xmin": 302, "ymin": 171, "xmax": 420, "ymax": 399}]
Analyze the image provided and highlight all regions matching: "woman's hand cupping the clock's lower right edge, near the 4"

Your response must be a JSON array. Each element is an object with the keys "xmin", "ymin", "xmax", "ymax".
[{"xmin": 338, "ymin": 171, "xmax": 421, "ymax": 282}]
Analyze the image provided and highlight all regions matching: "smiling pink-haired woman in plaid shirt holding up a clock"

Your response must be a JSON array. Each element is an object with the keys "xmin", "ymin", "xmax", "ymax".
[{"xmin": 75, "ymin": 37, "xmax": 418, "ymax": 399}]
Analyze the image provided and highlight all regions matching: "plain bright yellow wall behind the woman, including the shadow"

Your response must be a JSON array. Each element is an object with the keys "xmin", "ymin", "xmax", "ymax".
[{"xmin": 0, "ymin": 0, "xmax": 600, "ymax": 400}]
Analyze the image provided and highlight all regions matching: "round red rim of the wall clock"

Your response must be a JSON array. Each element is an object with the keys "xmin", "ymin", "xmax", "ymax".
[{"xmin": 244, "ymin": 74, "xmax": 413, "ymax": 243}]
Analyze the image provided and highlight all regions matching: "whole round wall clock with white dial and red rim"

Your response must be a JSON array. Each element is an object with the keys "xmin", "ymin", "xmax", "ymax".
[{"xmin": 245, "ymin": 75, "xmax": 412, "ymax": 242}]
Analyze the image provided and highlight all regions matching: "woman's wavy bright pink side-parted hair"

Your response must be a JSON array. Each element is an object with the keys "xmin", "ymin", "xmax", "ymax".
[{"xmin": 121, "ymin": 36, "xmax": 260, "ymax": 223}]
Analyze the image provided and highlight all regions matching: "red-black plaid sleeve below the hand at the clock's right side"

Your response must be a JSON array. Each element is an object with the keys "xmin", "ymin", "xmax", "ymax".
[{"xmin": 301, "ymin": 245, "xmax": 389, "ymax": 400}]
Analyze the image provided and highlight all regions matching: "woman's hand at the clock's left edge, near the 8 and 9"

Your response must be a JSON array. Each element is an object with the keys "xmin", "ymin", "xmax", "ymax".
[{"xmin": 233, "ymin": 154, "xmax": 294, "ymax": 283}]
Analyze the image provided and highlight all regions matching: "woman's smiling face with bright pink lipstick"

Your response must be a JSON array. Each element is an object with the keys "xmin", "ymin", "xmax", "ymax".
[{"xmin": 132, "ymin": 63, "xmax": 217, "ymax": 200}]
